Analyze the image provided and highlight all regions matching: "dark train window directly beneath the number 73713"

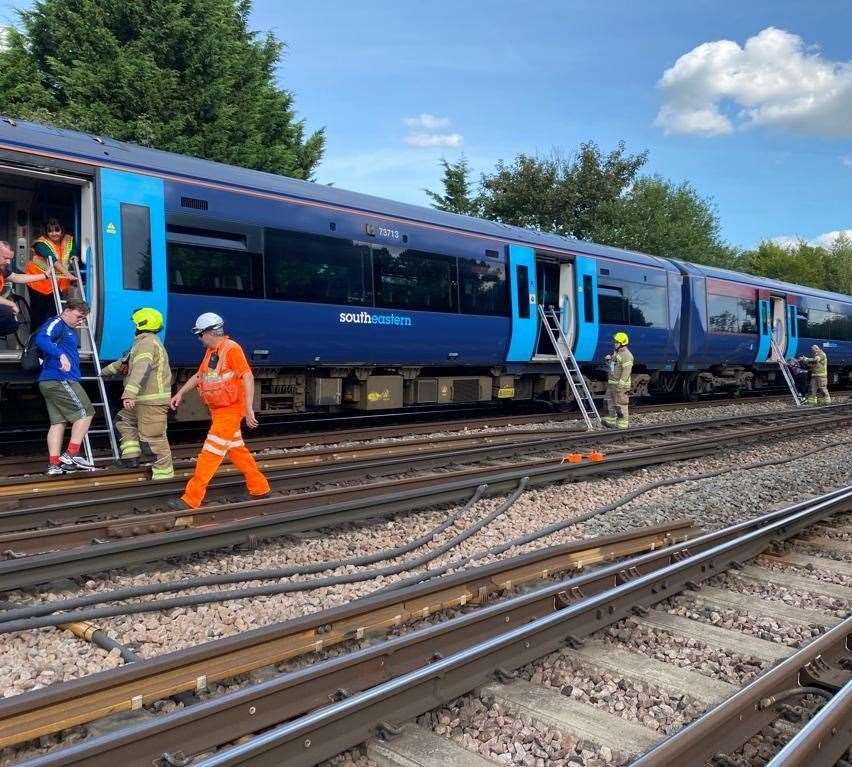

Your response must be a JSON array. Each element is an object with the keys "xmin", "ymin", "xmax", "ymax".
[{"xmin": 373, "ymin": 246, "xmax": 458, "ymax": 312}]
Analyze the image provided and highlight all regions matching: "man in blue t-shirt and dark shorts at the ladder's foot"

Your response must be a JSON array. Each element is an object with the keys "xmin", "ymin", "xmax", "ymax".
[{"xmin": 35, "ymin": 298, "xmax": 95, "ymax": 474}]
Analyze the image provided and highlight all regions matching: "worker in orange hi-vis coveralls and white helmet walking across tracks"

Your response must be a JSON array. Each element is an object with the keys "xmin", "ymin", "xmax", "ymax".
[{"xmin": 169, "ymin": 312, "xmax": 269, "ymax": 511}]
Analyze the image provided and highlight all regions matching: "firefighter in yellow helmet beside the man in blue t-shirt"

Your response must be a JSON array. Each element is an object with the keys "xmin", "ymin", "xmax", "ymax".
[{"xmin": 103, "ymin": 307, "xmax": 175, "ymax": 480}]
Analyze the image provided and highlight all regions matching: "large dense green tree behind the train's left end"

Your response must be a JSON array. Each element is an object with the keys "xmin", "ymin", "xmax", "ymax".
[{"xmin": 0, "ymin": 0, "xmax": 325, "ymax": 179}]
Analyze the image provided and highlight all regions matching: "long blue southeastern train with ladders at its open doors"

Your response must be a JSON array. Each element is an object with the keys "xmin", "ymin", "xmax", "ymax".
[{"xmin": 0, "ymin": 119, "xmax": 852, "ymax": 419}]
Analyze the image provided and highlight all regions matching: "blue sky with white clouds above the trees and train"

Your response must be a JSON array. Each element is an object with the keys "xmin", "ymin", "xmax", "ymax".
[{"xmin": 0, "ymin": 0, "xmax": 852, "ymax": 247}]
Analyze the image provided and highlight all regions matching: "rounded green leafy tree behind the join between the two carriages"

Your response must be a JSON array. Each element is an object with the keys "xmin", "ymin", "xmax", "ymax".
[{"xmin": 591, "ymin": 176, "xmax": 741, "ymax": 269}]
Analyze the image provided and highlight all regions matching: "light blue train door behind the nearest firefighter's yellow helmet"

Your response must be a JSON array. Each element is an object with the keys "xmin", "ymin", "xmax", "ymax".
[{"xmin": 98, "ymin": 169, "xmax": 168, "ymax": 359}]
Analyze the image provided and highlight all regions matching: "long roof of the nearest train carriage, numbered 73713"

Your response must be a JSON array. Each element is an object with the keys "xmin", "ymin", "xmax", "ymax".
[{"xmin": 0, "ymin": 118, "xmax": 676, "ymax": 271}]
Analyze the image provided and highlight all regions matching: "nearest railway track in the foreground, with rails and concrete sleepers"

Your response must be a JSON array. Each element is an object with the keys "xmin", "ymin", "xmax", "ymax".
[{"xmin": 8, "ymin": 487, "xmax": 852, "ymax": 767}]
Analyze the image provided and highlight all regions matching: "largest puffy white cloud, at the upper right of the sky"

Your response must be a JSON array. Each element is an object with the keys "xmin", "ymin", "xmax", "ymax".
[{"xmin": 655, "ymin": 27, "xmax": 852, "ymax": 136}]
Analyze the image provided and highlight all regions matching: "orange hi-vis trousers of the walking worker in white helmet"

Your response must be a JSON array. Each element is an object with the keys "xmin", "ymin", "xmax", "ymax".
[{"xmin": 181, "ymin": 405, "xmax": 269, "ymax": 509}]
